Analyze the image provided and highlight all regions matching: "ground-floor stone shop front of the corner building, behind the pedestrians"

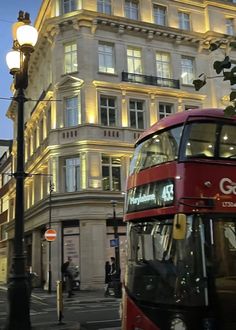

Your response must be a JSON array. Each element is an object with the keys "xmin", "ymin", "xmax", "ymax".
[{"xmin": 8, "ymin": 218, "xmax": 126, "ymax": 290}]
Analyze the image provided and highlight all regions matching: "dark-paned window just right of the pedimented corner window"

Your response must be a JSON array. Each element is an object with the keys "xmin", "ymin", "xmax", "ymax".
[{"xmin": 100, "ymin": 96, "xmax": 116, "ymax": 126}]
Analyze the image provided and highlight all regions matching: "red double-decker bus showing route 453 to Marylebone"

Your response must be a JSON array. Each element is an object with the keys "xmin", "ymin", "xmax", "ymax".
[{"xmin": 122, "ymin": 109, "xmax": 236, "ymax": 330}]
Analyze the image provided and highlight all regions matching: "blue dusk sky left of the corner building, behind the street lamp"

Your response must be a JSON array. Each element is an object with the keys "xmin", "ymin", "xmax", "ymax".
[{"xmin": 0, "ymin": 0, "xmax": 42, "ymax": 140}]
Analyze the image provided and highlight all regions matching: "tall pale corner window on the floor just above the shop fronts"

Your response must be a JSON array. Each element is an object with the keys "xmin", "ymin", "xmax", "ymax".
[{"xmin": 65, "ymin": 157, "xmax": 80, "ymax": 192}]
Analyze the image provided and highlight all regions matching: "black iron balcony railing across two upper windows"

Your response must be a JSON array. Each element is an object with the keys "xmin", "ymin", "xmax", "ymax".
[{"xmin": 122, "ymin": 71, "xmax": 180, "ymax": 89}]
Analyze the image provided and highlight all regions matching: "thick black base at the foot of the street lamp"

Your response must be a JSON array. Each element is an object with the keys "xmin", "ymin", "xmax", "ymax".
[{"xmin": 5, "ymin": 276, "xmax": 31, "ymax": 330}]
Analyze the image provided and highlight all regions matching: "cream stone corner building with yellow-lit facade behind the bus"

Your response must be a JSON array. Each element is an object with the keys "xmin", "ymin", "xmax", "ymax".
[{"xmin": 2, "ymin": 0, "xmax": 236, "ymax": 289}]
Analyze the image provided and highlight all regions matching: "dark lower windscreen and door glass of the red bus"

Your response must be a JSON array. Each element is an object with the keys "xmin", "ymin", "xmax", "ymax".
[{"xmin": 126, "ymin": 215, "xmax": 236, "ymax": 306}]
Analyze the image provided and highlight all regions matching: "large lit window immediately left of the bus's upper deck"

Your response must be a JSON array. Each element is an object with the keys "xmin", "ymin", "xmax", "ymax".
[{"xmin": 102, "ymin": 155, "xmax": 121, "ymax": 191}]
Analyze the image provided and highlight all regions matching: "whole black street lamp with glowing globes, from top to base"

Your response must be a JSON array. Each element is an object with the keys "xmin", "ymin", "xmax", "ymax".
[{"xmin": 6, "ymin": 11, "xmax": 38, "ymax": 330}]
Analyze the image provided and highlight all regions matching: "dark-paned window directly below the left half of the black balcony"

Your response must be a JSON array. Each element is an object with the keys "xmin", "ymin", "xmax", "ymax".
[{"xmin": 129, "ymin": 100, "xmax": 144, "ymax": 129}]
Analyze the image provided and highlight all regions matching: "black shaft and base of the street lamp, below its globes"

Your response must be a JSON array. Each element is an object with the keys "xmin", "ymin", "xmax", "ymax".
[{"xmin": 7, "ymin": 88, "xmax": 31, "ymax": 330}]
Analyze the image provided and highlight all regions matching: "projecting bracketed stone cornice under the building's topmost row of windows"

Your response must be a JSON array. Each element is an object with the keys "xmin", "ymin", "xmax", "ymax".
[{"xmin": 33, "ymin": 9, "xmax": 236, "ymax": 52}]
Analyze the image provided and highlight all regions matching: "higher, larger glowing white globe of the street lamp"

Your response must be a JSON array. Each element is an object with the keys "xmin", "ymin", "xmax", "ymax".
[{"xmin": 16, "ymin": 24, "xmax": 38, "ymax": 51}]
